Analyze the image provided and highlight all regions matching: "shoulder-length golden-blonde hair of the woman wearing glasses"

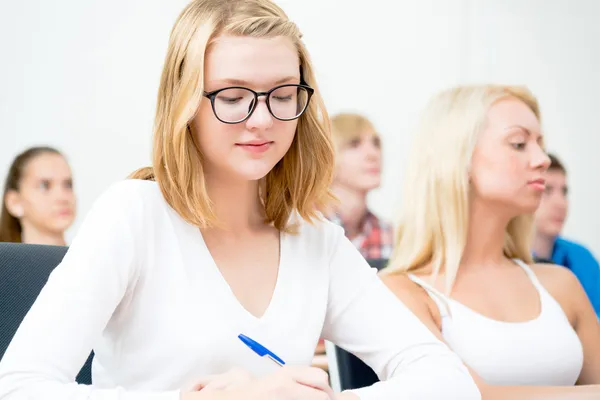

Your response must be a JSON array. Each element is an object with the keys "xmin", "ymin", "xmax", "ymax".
[{"xmin": 130, "ymin": 0, "xmax": 334, "ymax": 231}]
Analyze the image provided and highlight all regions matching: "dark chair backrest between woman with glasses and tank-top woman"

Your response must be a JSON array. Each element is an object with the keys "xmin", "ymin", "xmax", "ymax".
[{"xmin": 326, "ymin": 258, "xmax": 388, "ymax": 392}]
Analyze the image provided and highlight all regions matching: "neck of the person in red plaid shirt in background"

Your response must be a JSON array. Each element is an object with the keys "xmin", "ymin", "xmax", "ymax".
[{"xmin": 331, "ymin": 184, "xmax": 367, "ymax": 237}]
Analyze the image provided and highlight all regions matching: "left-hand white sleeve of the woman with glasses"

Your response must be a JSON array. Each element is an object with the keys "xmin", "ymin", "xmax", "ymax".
[{"xmin": 0, "ymin": 181, "xmax": 179, "ymax": 400}]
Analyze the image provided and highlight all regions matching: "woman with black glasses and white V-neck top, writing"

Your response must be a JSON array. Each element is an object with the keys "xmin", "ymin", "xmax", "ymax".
[{"xmin": 0, "ymin": 0, "xmax": 480, "ymax": 400}]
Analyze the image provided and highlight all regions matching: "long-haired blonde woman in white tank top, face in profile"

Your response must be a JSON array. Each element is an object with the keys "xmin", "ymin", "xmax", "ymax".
[{"xmin": 383, "ymin": 85, "xmax": 600, "ymax": 399}]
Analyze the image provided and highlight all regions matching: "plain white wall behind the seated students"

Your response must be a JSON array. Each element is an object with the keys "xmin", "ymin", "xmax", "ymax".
[{"xmin": 0, "ymin": 0, "xmax": 600, "ymax": 256}]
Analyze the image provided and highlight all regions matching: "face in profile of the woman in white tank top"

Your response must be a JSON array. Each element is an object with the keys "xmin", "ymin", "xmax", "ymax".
[{"xmin": 470, "ymin": 98, "xmax": 550, "ymax": 216}]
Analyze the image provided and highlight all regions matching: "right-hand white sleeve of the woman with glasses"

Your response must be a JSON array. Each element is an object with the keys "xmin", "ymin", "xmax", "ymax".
[{"xmin": 323, "ymin": 228, "xmax": 481, "ymax": 400}]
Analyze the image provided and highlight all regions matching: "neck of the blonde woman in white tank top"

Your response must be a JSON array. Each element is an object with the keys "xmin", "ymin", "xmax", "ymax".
[{"xmin": 460, "ymin": 202, "xmax": 511, "ymax": 270}]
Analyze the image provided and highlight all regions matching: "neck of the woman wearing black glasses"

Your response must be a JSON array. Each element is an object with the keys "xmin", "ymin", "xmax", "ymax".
[{"xmin": 205, "ymin": 174, "xmax": 265, "ymax": 233}]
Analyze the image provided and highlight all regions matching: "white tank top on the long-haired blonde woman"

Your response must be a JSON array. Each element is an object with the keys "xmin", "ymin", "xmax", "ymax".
[{"xmin": 409, "ymin": 260, "xmax": 583, "ymax": 386}]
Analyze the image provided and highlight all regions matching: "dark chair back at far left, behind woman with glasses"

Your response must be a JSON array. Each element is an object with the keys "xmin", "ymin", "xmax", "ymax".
[{"xmin": 0, "ymin": 243, "xmax": 94, "ymax": 385}]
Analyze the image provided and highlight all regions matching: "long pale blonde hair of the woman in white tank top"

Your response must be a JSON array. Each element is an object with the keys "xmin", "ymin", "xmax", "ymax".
[{"xmin": 384, "ymin": 85, "xmax": 540, "ymax": 294}]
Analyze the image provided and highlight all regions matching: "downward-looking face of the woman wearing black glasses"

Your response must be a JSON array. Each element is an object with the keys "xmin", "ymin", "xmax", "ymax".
[{"xmin": 192, "ymin": 36, "xmax": 300, "ymax": 180}]
